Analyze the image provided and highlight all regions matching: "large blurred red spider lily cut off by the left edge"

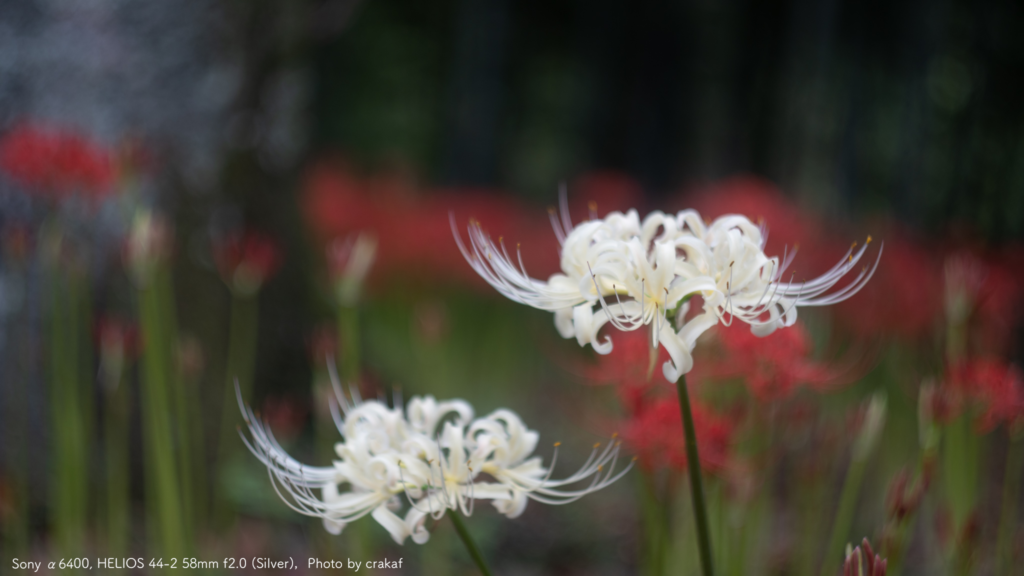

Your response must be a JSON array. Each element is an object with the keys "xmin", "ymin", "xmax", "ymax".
[{"xmin": 0, "ymin": 124, "xmax": 116, "ymax": 197}]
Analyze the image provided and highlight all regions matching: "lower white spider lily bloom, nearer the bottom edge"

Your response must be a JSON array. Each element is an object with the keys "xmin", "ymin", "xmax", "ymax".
[{"xmin": 239, "ymin": 379, "xmax": 633, "ymax": 544}]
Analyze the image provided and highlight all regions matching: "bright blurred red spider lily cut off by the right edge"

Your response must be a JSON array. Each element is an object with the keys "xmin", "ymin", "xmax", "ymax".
[{"xmin": 936, "ymin": 359, "xmax": 1024, "ymax": 433}]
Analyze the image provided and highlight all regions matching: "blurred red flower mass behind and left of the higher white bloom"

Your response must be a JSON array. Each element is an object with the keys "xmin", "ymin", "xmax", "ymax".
[{"xmin": 303, "ymin": 156, "xmax": 640, "ymax": 293}]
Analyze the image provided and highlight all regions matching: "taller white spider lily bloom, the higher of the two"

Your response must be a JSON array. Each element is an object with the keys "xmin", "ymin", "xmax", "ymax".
[{"xmin": 452, "ymin": 200, "xmax": 882, "ymax": 381}]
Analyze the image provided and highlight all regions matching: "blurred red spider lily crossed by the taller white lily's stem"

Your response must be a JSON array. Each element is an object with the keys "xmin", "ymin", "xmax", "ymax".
[{"xmin": 623, "ymin": 397, "xmax": 735, "ymax": 474}]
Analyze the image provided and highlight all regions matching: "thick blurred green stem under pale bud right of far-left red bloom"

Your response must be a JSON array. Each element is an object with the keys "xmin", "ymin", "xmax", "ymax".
[{"xmin": 138, "ymin": 279, "xmax": 185, "ymax": 556}]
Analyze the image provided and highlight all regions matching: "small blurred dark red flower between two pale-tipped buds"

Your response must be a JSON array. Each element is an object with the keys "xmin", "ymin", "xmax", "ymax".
[{"xmin": 213, "ymin": 231, "xmax": 281, "ymax": 294}]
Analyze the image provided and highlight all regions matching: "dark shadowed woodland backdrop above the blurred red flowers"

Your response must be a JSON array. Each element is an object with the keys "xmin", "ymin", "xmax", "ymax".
[{"xmin": 310, "ymin": 0, "xmax": 1024, "ymax": 235}]
